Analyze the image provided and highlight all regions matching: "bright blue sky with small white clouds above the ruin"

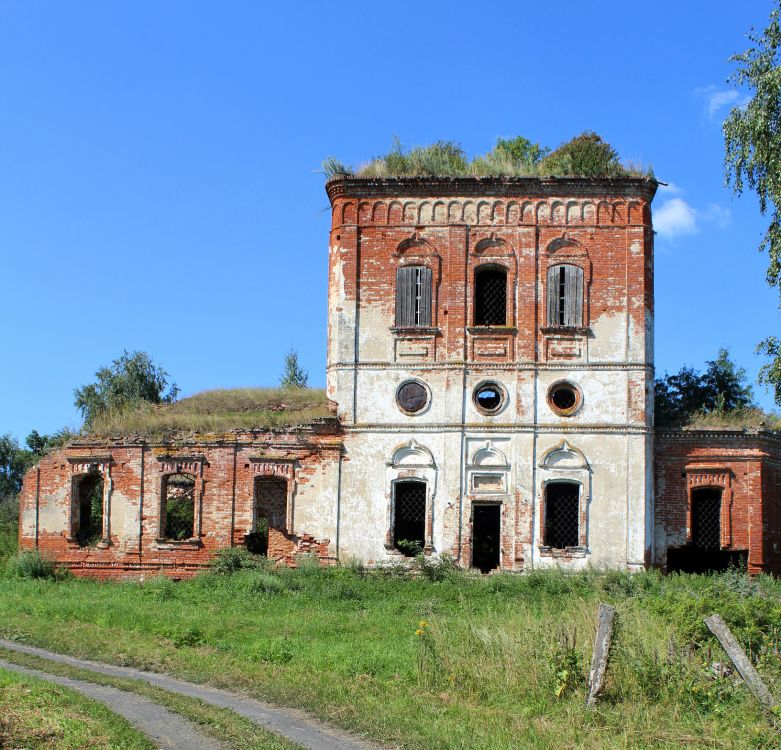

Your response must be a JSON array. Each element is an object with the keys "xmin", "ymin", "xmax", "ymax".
[{"xmin": 0, "ymin": 0, "xmax": 779, "ymax": 438}]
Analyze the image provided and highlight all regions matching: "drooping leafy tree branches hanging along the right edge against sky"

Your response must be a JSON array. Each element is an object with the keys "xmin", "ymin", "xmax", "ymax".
[{"xmin": 723, "ymin": 5, "xmax": 781, "ymax": 405}]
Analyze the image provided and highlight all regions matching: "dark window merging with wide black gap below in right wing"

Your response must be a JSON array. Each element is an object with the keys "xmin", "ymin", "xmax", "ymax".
[{"xmin": 667, "ymin": 487, "xmax": 748, "ymax": 573}]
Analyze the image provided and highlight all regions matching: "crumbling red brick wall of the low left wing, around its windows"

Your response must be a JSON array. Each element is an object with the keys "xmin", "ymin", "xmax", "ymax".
[{"xmin": 20, "ymin": 428, "xmax": 341, "ymax": 578}]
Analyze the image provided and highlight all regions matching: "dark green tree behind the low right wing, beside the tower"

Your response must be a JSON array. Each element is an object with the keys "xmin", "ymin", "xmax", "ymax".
[{"xmin": 654, "ymin": 348, "xmax": 755, "ymax": 425}]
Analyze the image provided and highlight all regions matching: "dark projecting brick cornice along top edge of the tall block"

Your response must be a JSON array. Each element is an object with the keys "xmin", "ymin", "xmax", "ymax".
[{"xmin": 325, "ymin": 177, "xmax": 658, "ymax": 205}]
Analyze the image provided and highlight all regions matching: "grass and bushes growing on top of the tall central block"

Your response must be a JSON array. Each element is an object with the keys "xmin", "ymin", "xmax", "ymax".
[{"xmin": 323, "ymin": 131, "xmax": 653, "ymax": 180}]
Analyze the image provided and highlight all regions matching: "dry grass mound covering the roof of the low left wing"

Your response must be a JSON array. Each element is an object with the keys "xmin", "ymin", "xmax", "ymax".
[{"xmin": 84, "ymin": 388, "xmax": 329, "ymax": 437}]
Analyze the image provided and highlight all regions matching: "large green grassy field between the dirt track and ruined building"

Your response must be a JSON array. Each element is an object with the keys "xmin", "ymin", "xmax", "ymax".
[{"xmin": 0, "ymin": 564, "xmax": 781, "ymax": 750}]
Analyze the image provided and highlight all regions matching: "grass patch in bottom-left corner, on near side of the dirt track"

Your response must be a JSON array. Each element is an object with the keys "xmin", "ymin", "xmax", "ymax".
[{"xmin": 0, "ymin": 669, "xmax": 155, "ymax": 750}]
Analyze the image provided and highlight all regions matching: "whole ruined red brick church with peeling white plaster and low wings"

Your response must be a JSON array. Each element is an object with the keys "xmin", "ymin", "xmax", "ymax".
[{"xmin": 20, "ymin": 177, "xmax": 781, "ymax": 577}]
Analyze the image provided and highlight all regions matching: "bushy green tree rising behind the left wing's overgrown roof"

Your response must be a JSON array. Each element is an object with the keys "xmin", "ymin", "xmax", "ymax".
[{"xmin": 73, "ymin": 351, "xmax": 179, "ymax": 427}]
